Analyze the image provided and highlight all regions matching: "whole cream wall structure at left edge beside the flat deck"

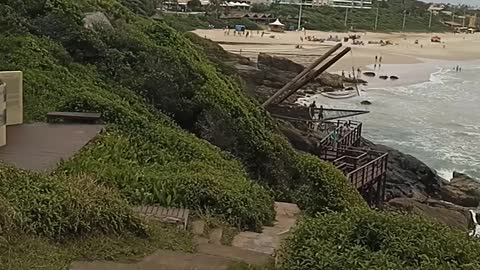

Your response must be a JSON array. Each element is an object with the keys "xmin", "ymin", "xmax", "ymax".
[{"xmin": 0, "ymin": 71, "xmax": 23, "ymax": 146}]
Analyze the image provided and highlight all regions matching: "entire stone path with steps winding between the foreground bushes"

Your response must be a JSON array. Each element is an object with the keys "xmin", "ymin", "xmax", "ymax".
[{"xmin": 70, "ymin": 202, "xmax": 300, "ymax": 270}]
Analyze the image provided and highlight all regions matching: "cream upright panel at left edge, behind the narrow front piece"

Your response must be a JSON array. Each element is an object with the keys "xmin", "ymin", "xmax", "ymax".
[{"xmin": 0, "ymin": 71, "xmax": 23, "ymax": 126}]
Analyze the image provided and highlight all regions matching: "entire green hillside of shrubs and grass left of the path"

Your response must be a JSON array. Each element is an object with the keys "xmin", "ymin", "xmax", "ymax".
[{"xmin": 0, "ymin": 0, "xmax": 480, "ymax": 269}]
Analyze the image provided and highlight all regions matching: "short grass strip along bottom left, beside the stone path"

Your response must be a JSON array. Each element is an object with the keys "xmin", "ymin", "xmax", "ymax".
[{"xmin": 0, "ymin": 223, "xmax": 194, "ymax": 270}]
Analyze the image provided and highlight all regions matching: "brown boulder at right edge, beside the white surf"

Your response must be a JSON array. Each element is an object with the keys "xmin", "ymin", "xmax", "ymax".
[{"xmin": 440, "ymin": 172, "xmax": 480, "ymax": 208}]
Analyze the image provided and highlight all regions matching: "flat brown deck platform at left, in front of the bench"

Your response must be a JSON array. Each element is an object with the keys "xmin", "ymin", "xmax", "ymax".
[{"xmin": 0, "ymin": 123, "xmax": 104, "ymax": 172}]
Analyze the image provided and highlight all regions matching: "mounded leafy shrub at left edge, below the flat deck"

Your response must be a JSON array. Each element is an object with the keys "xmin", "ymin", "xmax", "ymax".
[{"xmin": 0, "ymin": 164, "xmax": 145, "ymax": 238}]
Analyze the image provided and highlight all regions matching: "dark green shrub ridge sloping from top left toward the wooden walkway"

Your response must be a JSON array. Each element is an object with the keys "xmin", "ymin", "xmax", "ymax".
[{"xmin": 0, "ymin": 0, "xmax": 361, "ymax": 210}]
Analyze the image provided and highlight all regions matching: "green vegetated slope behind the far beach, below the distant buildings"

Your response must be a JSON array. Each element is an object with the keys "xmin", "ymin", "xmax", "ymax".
[{"xmin": 268, "ymin": 0, "xmax": 448, "ymax": 32}]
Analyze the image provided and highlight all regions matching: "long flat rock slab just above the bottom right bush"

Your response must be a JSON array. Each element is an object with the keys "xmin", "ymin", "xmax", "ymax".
[{"xmin": 388, "ymin": 198, "xmax": 473, "ymax": 232}]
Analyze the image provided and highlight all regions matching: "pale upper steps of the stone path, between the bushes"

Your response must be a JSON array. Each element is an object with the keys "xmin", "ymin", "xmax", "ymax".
[{"xmin": 232, "ymin": 202, "xmax": 300, "ymax": 255}]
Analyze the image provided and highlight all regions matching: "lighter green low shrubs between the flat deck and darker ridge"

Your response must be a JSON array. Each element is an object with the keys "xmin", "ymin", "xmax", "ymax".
[{"xmin": 0, "ymin": 31, "xmax": 274, "ymax": 229}]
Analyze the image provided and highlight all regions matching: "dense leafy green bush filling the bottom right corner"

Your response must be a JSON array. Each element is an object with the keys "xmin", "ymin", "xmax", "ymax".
[{"xmin": 281, "ymin": 209, "xmax": 480, "ymax": 270}]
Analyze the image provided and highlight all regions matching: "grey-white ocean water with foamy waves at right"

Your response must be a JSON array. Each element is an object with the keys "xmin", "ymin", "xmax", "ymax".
[{"xmin": 299, "ymin": 63, "xmax": 480, "ymax": 180}]
